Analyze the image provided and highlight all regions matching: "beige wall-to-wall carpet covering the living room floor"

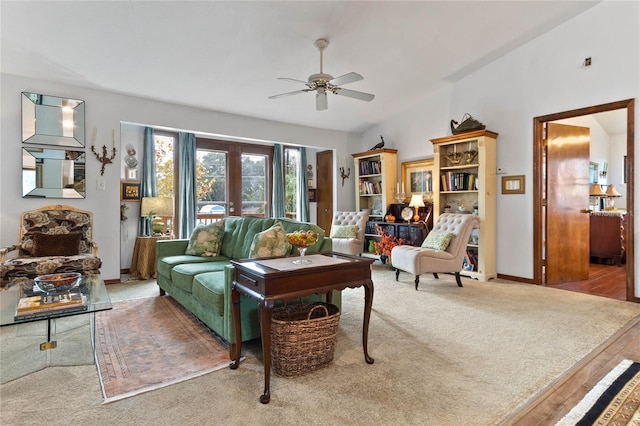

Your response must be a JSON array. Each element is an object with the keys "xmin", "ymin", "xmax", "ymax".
[{"xmin": 0, "ymin": 265, "xmax": 640, "ymax": 425}]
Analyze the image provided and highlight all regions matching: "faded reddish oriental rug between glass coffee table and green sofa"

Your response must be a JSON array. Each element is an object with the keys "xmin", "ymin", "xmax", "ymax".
[{"xmin": 96, "ymin": 296, "xmax": 229, "ymax": 403}]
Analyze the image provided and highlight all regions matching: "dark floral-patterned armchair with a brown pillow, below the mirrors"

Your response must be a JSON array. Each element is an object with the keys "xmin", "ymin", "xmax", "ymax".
[{"xmin": 0, "ymin": 205, "xmax": 102, "ymax": 286}]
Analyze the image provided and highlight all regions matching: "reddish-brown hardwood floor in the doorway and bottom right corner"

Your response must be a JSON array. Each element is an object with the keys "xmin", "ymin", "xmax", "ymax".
[{"xmin": 502, "ymin": 264, "xmax": 640, "ymax": 426}]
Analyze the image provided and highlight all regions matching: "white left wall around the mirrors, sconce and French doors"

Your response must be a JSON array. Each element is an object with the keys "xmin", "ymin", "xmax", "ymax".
[{"xmin": 0, "ymin": 74, "xmax": 358, "ymax": 280}]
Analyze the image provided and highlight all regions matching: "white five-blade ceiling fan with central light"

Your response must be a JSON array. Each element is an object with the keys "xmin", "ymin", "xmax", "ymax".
[{"xmin": 269, "ymin": 38, "xmax": 374, "ymax": 111}]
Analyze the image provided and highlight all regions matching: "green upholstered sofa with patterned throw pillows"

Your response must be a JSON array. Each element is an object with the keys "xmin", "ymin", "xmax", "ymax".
[{"xmin": 156, "ymin": 216, "xmax": 340, "ymax": 343}]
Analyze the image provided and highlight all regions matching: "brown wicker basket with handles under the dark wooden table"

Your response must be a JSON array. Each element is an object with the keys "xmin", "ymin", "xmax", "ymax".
[{"xmin": 271, "ymin": 302, "xmax": 340, "ymax": 376}]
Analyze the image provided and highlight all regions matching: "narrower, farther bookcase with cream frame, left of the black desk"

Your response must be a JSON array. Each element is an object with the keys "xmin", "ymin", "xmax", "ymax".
[{"xmin": 352, "ymin": 148, "xmax": 398, "ymax": 246}]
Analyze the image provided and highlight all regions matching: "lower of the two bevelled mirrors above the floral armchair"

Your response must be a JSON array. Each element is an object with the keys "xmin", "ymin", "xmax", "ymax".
[{"xmin": 22, "ymin": 148, "xmax": 86, "ymax": 198}]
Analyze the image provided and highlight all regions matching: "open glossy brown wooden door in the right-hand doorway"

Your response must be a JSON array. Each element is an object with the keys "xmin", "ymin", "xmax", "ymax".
[{"xmin": 545, "ymin": 123, "xmax": 589, "ymax": 284}]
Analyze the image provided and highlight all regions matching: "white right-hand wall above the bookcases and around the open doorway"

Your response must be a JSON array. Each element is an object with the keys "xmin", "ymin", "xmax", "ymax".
[{"xmin": 361, "ymin": 1, "xmax": 640, "ymax": 296}]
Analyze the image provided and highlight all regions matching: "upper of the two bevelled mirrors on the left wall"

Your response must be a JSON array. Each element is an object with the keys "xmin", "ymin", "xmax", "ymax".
[{"xmin": 22, "ymin": 92, "xmax": 85, "ymax": 147}]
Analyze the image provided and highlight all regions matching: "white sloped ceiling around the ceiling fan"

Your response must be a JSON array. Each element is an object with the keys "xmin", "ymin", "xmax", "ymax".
[{"xmin": 0, "ymin": 1, "xmax": 598, "ymax": 132}]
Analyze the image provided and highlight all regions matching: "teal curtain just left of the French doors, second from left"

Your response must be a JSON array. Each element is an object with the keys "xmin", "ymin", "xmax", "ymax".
[{"xmin": 178, "ymin": 132, "xmax": 197, "ymax": 238}]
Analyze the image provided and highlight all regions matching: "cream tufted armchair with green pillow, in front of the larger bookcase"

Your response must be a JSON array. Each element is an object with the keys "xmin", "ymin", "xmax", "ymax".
[{"xmin": 391, "ymin": 213, "xmax": 479, "ymax": 290}]
